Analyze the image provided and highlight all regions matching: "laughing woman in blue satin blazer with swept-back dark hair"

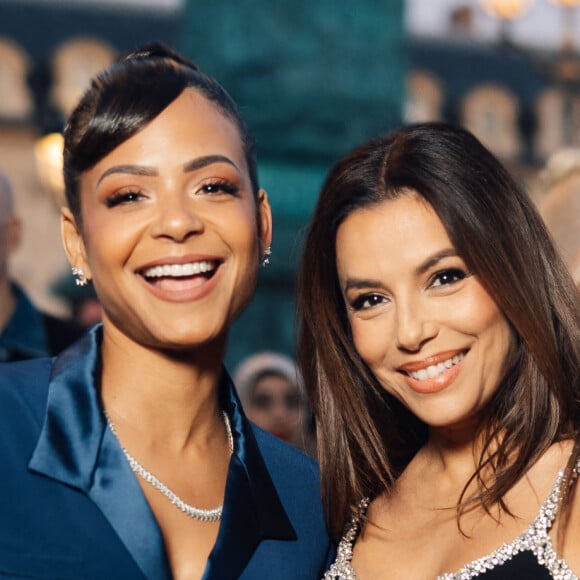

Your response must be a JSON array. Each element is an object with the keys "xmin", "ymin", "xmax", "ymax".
[{"xmin": 0, "ymin": 44, "xmax": 330, "ymax": 580}]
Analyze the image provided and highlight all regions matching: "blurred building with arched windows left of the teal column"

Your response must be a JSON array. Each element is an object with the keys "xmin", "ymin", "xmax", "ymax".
[{"xmin": 0, "ymin": 0, "xmax": 178, "ymax": 315}]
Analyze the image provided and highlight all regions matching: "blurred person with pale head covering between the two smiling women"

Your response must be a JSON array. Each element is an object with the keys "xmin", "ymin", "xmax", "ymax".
[{"xmin": 233, "ymin": 352, "xmax": 308, "ymax": 448}]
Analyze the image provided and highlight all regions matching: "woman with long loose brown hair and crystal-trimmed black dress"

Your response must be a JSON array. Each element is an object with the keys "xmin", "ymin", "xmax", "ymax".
[{"xmin": 299, "ymin": 123, "xmax": 580, "ymax": 580}]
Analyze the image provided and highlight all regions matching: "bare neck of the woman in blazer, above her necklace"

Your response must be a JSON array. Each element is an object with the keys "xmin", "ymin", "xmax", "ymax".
[{"xmin": 101, "ymin": 325, "xmax": 223, "ymax": 447}]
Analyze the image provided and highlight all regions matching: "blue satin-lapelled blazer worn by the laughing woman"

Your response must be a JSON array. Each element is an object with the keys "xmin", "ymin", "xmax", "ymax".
[{"xmin": 0, "ymin": 327, "xmax": 331, "ymax": 580}]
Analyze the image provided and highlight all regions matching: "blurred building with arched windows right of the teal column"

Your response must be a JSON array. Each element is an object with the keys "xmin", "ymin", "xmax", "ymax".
[{"xmin": 403, "ymin": 4, "xmax": 580, "ymax": 198}]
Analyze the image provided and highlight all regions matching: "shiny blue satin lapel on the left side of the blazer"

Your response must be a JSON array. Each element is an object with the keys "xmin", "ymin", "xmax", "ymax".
[{"xmin": 29, "ymin": 327, "xmax": 171, "ymax": 580}]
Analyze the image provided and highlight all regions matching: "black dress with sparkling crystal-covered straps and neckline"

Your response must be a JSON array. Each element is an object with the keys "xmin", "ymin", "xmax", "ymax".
[{"xmin": 323, "ymin": 461, "xmax": 580, "ymax": 580}]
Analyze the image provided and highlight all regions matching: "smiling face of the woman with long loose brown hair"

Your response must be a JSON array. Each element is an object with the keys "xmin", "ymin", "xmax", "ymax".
[{"xmin": 336, "ymin": 192, "xmax": 512, "ymax": 427}]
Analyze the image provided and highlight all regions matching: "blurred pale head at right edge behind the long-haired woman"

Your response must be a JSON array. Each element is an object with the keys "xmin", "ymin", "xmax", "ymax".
[{"xmin": 539, "ymin": 148, "xmax": 580, "ymax": 288}]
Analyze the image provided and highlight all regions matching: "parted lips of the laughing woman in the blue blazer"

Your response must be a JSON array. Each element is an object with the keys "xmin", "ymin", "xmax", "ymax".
[{"xmin": 135, "ymin": 254, "xmax": 223, "ymax": 302}]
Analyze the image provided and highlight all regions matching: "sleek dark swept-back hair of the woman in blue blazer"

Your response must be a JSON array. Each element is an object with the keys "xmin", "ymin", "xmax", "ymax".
[{"xmin": 64, "ymin": 43, "xmax": 258, "ymax": 224}]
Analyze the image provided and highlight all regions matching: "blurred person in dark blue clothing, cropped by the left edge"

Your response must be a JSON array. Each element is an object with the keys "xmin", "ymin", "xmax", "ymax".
[{"xmin": 0, "ymin": 173, "xmax": 83, "ymax": 362}]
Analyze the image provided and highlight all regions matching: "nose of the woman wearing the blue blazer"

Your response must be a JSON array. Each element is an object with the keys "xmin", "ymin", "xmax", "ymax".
[{"xmin": 152, "ymin": 190, "xmax": 204, "ymax": 242}]
